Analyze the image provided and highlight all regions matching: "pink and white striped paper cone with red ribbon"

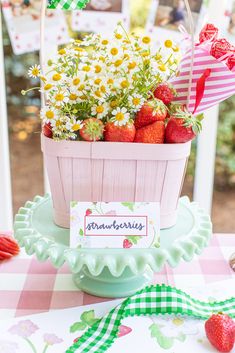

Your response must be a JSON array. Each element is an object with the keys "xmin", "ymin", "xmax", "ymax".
[{"xmin": 171, "ymin": 46, "xmax": 235, "ymax": 114}]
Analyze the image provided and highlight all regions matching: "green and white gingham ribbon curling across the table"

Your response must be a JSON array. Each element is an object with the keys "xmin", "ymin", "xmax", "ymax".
[{"xmin": 66, "ymin": 285, "xmax": 235, "ymax": 353}]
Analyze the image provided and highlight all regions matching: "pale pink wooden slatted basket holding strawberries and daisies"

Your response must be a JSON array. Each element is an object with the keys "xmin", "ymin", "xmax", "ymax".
[{"xmin": 41, "ymin": 135, "xmax": 191, "ymax": 228}]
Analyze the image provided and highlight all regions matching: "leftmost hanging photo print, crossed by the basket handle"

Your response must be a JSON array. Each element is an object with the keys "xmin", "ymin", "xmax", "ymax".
[{"xmin": 2, "ymin": 0, "xmax": 69, "ymax": 55}]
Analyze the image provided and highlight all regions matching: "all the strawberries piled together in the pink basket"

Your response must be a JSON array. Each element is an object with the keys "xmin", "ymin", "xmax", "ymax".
[{"xmin": 43, "ymin": 83, "xmax": 201, "ymax": 144}]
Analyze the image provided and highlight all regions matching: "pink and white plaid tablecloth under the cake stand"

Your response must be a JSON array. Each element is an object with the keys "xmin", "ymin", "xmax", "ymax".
[{"xmin": 0, "ymin": 234, "xmax": 235, "ymax": 319}]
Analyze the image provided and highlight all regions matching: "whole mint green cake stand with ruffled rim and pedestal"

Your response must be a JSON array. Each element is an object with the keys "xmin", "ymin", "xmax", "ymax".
[{"xmin": 14, "ymin": 195, "xmax": 212, "ymax": 298}]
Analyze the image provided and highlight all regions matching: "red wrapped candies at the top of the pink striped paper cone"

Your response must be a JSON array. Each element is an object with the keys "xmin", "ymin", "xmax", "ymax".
[{"xmin": 199, "ymin": 23, "xmax": 235, "ymax": 71}]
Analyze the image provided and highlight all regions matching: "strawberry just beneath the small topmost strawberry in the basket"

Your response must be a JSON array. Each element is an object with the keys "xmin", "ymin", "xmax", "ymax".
[{"xmin": 135, "ymin": 99, "xmax": 167, "ymax": 129}]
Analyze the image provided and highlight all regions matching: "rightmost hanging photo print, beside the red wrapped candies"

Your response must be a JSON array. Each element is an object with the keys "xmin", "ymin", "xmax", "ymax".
[{"xmin": 147, "ymin": 0, "xmax": 208, "ymax": 42}]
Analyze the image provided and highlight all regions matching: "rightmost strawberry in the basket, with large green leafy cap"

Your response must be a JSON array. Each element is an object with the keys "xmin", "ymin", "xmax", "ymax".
[{"xmin": 165, "ymin": 105, "xmax": 201, "ymax": 143}]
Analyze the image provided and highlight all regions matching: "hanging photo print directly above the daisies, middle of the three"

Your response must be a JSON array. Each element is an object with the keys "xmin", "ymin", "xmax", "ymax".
[{"xmin": 72, "ymin": 0, "xmax": 130, "ymax": 34}]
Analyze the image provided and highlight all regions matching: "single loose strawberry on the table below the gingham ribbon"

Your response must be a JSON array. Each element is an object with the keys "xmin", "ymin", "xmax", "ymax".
[{"xmin": 205, "ymin": 314, "xmax": 235, "ymax": 352}]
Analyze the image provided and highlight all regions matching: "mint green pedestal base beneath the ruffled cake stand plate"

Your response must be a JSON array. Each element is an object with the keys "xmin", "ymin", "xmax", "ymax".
[{"xmin": 73, "ymin": 268, "xmax": 153, "ymax": 298}]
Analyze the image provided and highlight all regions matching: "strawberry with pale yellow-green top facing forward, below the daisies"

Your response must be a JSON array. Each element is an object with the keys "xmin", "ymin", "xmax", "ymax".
[{"xmin": 79, "ymin": 118, "xmax": 104, "ymax": 142}]
